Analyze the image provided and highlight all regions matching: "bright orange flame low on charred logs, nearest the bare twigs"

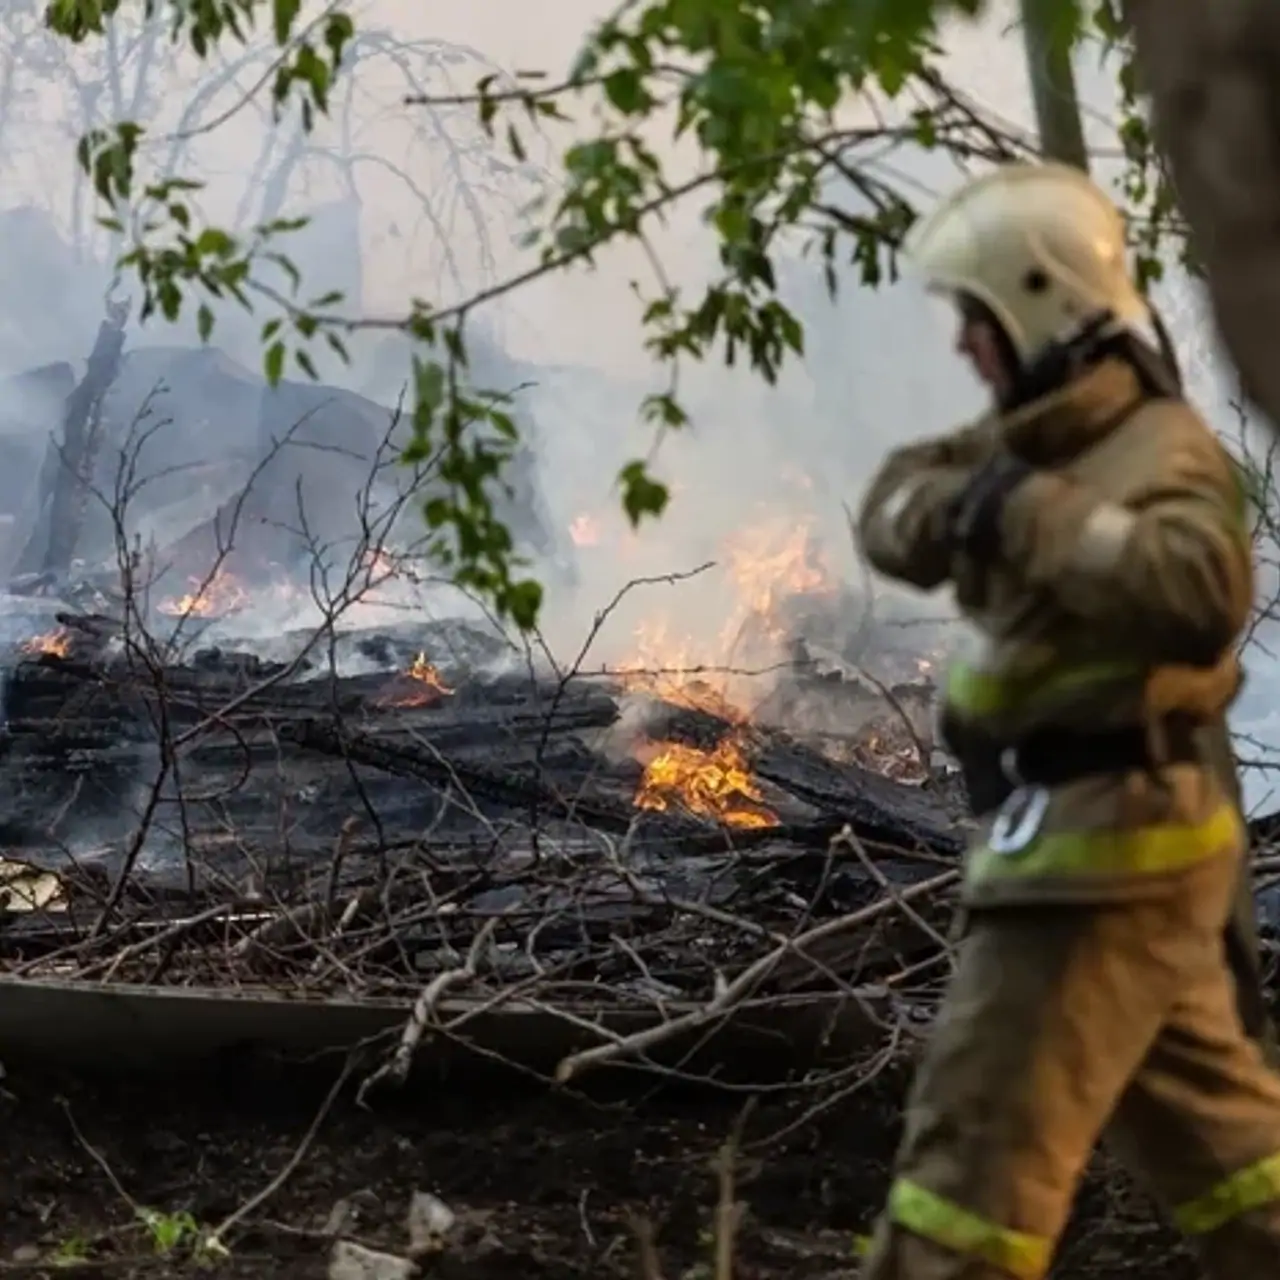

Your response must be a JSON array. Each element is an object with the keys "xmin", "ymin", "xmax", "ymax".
[{"xmin": 635, "ymin": 733, "xmax": 778, "ymax": 828}]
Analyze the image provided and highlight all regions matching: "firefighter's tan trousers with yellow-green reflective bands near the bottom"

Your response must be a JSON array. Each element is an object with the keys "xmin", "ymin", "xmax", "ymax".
[{"xmin": 863, "ymin": 859, "xmax": 1280, "ymax": 1280}]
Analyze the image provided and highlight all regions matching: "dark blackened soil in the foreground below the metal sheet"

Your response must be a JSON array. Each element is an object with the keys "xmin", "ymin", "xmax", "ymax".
[{"xmin": 0, "ymin": 1059, "xmax": 1193, "ymax": 1280}]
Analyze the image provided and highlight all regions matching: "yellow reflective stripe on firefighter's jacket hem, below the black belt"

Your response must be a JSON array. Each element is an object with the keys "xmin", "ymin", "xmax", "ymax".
[{"xmin": 965, "ymin": 804, "xmax": 1244, "ymax": 884}]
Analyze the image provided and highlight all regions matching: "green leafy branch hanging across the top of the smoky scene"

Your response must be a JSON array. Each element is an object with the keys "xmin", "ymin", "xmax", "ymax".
[{"xmin": 46, "ymin": 0, "xmax": 1116, "ymax": 627}]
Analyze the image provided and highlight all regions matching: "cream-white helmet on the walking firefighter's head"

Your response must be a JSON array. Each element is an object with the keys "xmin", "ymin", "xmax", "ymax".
[{"xmin": 902, "ymin": 164, "xmax": 1151, "ymax": 361}]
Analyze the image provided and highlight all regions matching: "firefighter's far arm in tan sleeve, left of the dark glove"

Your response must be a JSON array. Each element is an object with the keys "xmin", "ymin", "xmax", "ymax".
[{"xmin": 858, "ymin": 424, "xmax": 993, "ymax": 590}]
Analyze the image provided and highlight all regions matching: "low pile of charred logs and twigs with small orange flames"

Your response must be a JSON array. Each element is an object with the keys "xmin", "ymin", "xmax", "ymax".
[{"xmin": 0, "ymin": 613, "xmax": 1261, "ymax": 1085}]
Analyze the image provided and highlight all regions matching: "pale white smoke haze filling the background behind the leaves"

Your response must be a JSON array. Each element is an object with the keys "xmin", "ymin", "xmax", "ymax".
[{"xmin": 0, "ymin": 0, "xmax": 1280, "ymax": 799}]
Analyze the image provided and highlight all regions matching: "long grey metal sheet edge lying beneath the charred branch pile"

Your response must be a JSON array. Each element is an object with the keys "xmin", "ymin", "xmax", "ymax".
[{"xmin": 0, "ymin": 979, "xmax": 882, "ymax": 1074}]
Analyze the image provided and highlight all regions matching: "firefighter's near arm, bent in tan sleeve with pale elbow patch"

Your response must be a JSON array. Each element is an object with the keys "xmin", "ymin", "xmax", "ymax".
[{"xmin": 1001, "ymin": 428, "xmax": 1253, "ymax": 666}]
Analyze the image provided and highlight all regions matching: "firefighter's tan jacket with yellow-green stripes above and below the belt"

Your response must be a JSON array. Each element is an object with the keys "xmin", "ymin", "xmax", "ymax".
[{"xmin": 859, "ymin": 360, "xmax": 1253, "ymax": 906}]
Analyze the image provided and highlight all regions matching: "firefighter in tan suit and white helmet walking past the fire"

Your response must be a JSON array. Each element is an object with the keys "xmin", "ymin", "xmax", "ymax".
[{"xmin": 859, "ymin": 164, "xmax": 1280, "ymax": 1280}]
